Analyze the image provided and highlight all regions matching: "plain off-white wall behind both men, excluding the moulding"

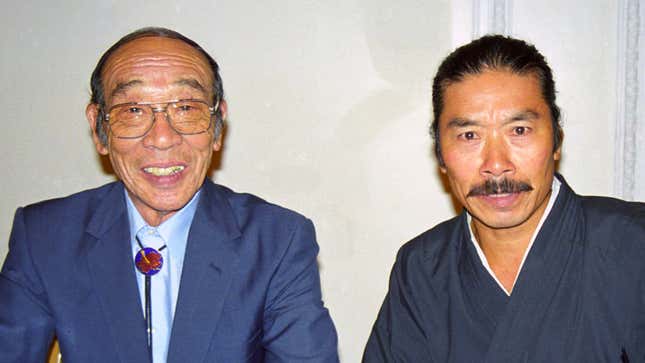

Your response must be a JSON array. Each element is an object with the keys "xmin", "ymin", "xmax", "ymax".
[{"xmin": 0, "ymin": 0, "xmax": 616, "ymax": 362}]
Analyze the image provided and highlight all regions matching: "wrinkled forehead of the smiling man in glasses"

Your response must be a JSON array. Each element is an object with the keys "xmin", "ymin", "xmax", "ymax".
[{"xmin": 101, "ymin": 36, "xmax": 213, "ymax": 103}]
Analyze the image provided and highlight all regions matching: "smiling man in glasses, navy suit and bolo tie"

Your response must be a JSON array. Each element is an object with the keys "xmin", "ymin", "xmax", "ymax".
[{"xmin": 0, "ymin": 28, "xmax": 338, "ymax": 363}]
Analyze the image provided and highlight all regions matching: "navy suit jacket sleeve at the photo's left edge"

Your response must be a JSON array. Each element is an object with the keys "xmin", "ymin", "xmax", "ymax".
[{"xmin": 0, "ymin": 209, "xmax": 54, "ymax": 363}]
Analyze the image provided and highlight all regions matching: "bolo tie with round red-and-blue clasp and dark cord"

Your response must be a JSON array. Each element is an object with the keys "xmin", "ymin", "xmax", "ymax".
[{"xmin": 134, "ymin": 236, "xmax": 166, "ymax": 362}]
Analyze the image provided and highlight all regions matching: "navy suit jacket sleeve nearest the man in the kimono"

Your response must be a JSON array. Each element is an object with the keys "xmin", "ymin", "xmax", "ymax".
[{"xmin": 264, "ymin": 220, "xmax": 338, "ymax": 363}]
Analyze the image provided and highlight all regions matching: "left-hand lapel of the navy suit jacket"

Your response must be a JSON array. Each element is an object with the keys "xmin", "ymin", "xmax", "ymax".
[{"xmin": 86, "ymin": 183, "xmax": 149, "ymax": 362}]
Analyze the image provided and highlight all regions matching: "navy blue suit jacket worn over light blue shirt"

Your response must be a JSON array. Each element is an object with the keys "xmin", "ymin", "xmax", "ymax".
[{"xmin": 0, "ymin": 181, "xmax": 338, "ymax": 363}]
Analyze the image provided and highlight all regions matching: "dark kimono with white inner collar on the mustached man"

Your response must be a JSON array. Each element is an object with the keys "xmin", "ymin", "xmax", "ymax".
[{"xmin": 363, "ymin": 176, "xmax": 645, "ymax": 363}]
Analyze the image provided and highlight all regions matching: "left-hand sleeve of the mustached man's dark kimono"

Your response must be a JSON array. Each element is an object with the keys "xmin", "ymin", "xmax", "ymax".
[{"xmin": 363, "ymin": 246, "xmax": 433, "ymax": 363}]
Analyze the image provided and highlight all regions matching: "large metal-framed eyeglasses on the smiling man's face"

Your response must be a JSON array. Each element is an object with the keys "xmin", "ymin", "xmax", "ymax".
[{"xmin": 105, "ymin": 99, "xmax": 219, "ymax": 139}]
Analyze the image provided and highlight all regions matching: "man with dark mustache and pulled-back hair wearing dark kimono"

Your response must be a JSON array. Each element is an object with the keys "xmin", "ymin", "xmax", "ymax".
[{"xmin": 364, "ymin": 36, "xmax": 645, "ymax": 362}]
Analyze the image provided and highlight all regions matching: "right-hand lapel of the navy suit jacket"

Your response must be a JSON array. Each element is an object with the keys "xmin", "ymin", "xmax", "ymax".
[{"xmin": 168, "ymin": 181, "xmax": 240, "ymax": 362}]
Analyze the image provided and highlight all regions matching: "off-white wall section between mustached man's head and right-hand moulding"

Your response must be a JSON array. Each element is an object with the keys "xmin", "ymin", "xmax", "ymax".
[{"xmin": 513, "ymin": 0, "xmax": 617, "ymax": 195}]
